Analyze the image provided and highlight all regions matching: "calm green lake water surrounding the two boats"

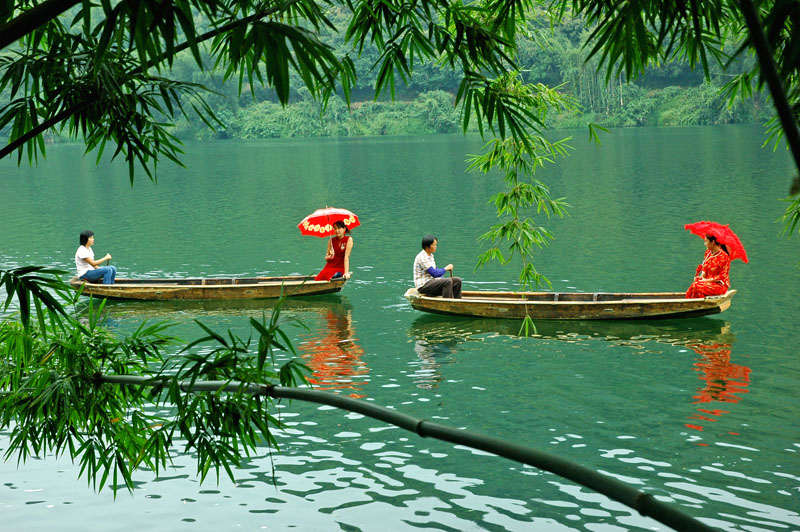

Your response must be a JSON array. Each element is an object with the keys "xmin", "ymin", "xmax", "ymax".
[{"xmin": 0, "ymin": 126, "xmax": 800, "ymax": 532}]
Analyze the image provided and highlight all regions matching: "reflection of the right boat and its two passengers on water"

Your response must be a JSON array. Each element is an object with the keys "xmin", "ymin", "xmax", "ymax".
[{"xmin": 408, "ymin": 316, "xmax": 750, "ymax": 430}]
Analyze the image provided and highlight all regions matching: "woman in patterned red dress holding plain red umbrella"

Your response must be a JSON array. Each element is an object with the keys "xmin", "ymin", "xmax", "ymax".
[{"xmin": 685, "ymin": 222, "xmax": 747, "ymax": 299}]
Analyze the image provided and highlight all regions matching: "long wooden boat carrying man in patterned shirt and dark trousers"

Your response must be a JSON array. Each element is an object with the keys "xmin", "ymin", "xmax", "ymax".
[{"xmin": 405, "ymin": 288, "xmax": 736, "ymax": 320}]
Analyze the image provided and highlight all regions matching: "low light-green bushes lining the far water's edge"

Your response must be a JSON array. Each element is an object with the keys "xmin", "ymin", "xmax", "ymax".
[{"xmin": 170, "ymin": 72, "xmax": 772, "ymax": 139}]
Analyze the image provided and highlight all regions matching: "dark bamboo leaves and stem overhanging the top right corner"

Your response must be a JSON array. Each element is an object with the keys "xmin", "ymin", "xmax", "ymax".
[{"xmin": 552, "ymin": 0, "xmax": 800, "ymax": 225}]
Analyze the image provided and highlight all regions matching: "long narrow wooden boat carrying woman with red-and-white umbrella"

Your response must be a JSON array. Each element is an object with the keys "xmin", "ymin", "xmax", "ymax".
[{"xmin": 69, "ymin": 275, "xmax": 347, "ymax": 301}]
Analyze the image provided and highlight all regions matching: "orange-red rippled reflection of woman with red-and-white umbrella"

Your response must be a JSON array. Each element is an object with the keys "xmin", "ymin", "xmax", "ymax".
[{"xmin": 296, "ymin": 296, "xmax": 369, "ymax": 398}]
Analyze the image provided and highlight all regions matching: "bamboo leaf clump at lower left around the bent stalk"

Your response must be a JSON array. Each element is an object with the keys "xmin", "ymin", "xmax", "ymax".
[{"xmin": 0, "ymin": 268, "xmax": 310, "ymax": 493}]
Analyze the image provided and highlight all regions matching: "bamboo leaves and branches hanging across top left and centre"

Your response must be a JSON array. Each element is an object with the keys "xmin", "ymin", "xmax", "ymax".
[{"xmin": 0, "ymin": 0, "xmax": 564, "ymax": 180}]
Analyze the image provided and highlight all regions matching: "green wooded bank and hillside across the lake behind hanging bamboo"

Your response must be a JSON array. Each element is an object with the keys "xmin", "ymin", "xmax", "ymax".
[{"xmin": 167, "ymin": 10, "xmax": 774, "ymax": 139}]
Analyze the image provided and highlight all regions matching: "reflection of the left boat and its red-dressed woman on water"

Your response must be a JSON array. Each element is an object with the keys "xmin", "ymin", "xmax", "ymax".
[{"xmin": 79, "ymin": 295, "xmax": 369, "ymax": 397}]
